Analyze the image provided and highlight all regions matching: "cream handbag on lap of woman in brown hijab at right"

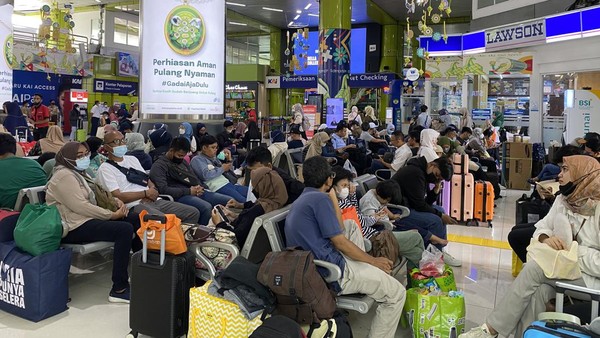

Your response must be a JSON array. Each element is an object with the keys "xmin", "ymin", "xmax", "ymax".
[{"xmin": 527, "ymin": 238, "xmax": 581, "ymax": 280}]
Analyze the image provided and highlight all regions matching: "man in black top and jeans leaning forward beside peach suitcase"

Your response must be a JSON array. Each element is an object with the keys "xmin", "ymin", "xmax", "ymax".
[{"xmin": 392, "ymin": 157, "xmax": 462, "ymax": 266}]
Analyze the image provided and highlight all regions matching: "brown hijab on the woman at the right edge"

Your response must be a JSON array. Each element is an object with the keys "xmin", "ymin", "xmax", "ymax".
[{"xmin": 563, "ymin": 155, "xmax": 600, "ymax": 216}]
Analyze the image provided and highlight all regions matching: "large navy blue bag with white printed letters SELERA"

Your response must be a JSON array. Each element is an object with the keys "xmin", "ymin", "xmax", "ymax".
[{"xmin": 0, "ymin": 242, "xmax": 71, "ymax": 322}]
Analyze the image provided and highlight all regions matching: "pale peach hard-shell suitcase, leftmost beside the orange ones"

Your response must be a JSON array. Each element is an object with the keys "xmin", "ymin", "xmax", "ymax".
[{"xmin": 450, "ymin": 174, "xmax": 475, "ymax": 222}]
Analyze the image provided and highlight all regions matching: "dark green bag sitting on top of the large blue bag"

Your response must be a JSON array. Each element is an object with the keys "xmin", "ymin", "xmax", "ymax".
[{"xmin": 13, "ymin": 204, "xmax": 63, "ymax": 256}]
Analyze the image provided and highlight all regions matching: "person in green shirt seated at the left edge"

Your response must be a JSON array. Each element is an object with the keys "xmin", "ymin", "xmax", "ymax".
[{"xmin": 0, "ymin": 133, "xmax": 46, "ymax": 209}]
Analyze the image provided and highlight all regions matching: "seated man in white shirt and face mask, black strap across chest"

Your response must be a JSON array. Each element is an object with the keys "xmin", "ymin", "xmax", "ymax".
[{"xmin": 96, "ymin": 131, "xmax": 200, "ymax": 224}]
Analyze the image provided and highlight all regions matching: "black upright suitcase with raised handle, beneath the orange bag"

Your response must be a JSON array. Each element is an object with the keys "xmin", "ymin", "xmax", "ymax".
[{"xmin": 129, "ymin": 215, "xmax": 195, "ymax": 338}]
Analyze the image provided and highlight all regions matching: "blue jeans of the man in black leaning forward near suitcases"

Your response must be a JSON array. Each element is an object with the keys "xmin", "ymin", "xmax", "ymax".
[{"xmin": 395, "ymin": 205, "xmax": 447, "ymax": 250}]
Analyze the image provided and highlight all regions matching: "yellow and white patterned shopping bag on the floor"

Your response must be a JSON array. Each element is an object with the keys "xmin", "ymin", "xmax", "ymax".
[{"xmin": 187, "ymin": 281, "xmax": 262, "ymax": 338}]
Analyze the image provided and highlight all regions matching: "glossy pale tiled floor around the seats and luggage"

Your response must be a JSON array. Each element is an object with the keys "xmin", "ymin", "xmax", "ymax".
[{"xmin": 0, "ymin": 191, "xmax": 523, "ymax": 338}]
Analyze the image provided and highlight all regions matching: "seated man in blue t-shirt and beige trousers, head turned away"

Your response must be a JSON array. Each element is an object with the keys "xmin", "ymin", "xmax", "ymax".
[{"xmin": 285, "ymin": 156, "xmax": 406, "ymax": 338}]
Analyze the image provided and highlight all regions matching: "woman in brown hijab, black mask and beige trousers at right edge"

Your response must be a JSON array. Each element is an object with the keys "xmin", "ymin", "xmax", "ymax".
[{"xmin": 459, "ymin": 155, "xmax": 600, "ymax": 338}]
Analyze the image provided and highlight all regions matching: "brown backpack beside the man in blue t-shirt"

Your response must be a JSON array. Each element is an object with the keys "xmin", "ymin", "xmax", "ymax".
[{"xmin": 257, "ymin": 248, "xmax": 336, "ymax": 325}]
